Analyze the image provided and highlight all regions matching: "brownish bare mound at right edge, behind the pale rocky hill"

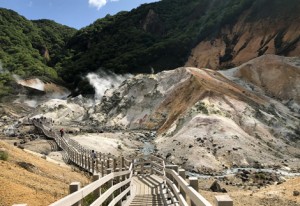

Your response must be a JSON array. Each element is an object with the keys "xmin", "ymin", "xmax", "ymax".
[{"xmin": 222, "ymin": 55, "xmax": 300, "ymax": 106}]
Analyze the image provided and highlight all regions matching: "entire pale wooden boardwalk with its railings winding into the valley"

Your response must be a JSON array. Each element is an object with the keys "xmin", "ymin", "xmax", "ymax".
[{"xmin": 25, "ymin": 117, "xmax": 233, "ymax": 206}]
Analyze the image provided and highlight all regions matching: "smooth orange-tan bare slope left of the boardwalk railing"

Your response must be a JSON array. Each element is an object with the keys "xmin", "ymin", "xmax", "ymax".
[{"xmin": 0, "ymin": 141, "xmax": 89, "ymax": 206}]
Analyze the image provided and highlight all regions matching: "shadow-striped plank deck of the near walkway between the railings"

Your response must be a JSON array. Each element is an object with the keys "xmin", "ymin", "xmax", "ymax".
[{"xmin": 124, "ymin": 175, "xmax": 167, "ymax": 206}]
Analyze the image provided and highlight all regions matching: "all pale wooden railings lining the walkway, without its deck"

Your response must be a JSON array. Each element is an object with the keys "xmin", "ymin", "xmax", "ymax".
[{"xmin": 13, "ymin": 119, "xmax": 233, "ymax": 206}]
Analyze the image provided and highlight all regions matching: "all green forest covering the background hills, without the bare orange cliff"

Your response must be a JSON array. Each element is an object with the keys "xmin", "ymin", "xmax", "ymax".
[{"xmin": 0, "ymin": 0, "xmax": 300, "ymax": 97}]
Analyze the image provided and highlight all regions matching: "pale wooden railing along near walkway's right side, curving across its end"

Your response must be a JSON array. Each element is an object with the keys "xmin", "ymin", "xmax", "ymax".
[{"xmin": 133, "ymin": 155, "xmax": 233, "ymax": 206}]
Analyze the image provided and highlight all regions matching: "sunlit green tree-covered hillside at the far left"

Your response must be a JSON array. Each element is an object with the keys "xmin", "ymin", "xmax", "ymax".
[{"xmin": 0, "ymin": 9, "xmax": 76, "ymax": 96}]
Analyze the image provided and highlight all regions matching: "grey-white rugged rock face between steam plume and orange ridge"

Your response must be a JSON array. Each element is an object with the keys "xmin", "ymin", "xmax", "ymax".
[{"xmin": 91, "ymin": 69, "xmax": 191, "ymax": 130}]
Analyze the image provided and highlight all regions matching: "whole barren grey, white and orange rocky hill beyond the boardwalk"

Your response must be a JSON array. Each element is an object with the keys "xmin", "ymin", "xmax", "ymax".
[{"xmin": 90, "ymin": 56, "xmax": 300, "ymax": 172}]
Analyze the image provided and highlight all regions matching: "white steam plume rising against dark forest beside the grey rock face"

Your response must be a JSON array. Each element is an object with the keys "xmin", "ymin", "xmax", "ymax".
[{"xmin": 86, "ymin": 70, "xmax": 132, "ymax": 100}]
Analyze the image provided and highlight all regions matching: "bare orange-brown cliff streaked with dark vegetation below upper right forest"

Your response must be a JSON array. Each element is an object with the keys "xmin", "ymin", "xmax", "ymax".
[{"xmin": 186, "ymin": 14, "xmax": 300, "ymax": 69}]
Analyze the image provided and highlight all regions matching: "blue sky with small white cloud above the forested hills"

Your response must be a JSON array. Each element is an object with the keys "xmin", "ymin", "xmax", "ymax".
[{"xmin": 0, "ymin": 0, "xmax": 159, "ymax": 29}]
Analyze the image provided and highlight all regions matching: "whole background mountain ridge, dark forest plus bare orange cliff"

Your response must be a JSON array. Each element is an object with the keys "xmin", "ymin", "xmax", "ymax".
[{"xmin": 0, "ymin": 0, "xmax": 300, "ymax": 94}]
